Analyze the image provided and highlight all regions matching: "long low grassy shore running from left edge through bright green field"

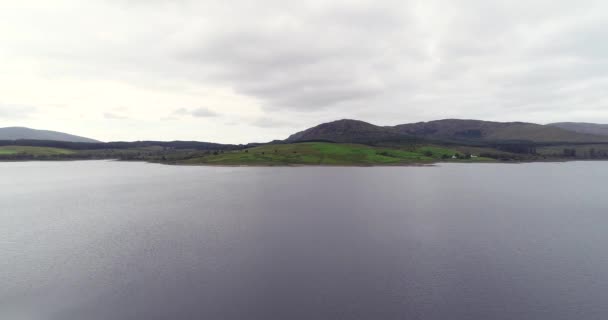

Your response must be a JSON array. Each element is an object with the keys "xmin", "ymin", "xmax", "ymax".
[{"xmin": 0, "ymin": 142, "xmax": 492, "ymax": 166}]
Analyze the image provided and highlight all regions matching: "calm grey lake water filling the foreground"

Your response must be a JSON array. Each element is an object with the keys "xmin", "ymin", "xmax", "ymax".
[{"xmin": 0, "ymin": 161, "xmax": 608, "ymax": 320}]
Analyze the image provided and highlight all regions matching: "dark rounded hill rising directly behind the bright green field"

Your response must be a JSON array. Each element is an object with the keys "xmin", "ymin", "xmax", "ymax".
[{"xmin": 286, "ymin": 119, "xmax": 410, "ymax": 143}]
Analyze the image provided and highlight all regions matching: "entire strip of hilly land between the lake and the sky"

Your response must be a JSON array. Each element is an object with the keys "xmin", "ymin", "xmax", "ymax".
[{"xmin": 7, "ymin": 119, "xmax": 608, "ymax": 165}]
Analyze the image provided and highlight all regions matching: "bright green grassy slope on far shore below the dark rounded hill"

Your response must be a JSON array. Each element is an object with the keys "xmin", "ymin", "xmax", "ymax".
[{"xmin": 175, "ymin": 142, "xmax": 490, "ymax": 166}]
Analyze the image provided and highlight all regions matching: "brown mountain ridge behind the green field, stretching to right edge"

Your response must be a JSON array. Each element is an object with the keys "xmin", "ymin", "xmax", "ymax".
[{"xmin": 287, "ymin": 119, "xmax": 608, "ymax": 143}]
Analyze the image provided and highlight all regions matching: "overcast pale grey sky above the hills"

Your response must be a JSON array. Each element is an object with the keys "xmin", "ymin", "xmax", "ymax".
[{"xmin": 0, "ymin": 0, "xmax": 608, "ymax": 143}]
